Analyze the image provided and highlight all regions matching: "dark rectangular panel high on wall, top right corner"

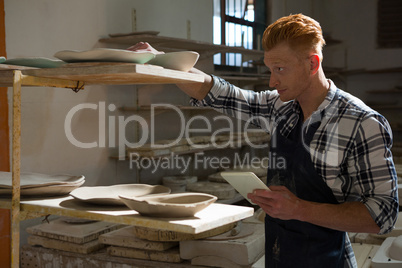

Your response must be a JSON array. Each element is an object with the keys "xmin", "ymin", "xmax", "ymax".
[{"xmin": 377, "ymin": 0, "xmax": 402, "ymax": 48}]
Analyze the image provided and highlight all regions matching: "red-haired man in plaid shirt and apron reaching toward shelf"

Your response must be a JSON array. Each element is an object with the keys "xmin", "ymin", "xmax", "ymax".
[{"xmin": 131, "ymin": 14, "xmax": 398, "ymax": 267}]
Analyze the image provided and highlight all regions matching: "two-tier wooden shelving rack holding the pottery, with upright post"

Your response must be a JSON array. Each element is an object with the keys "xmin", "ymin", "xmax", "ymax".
[{"xmin": 0, "ymin": 63, "xmax": 253, "ymax": 267}]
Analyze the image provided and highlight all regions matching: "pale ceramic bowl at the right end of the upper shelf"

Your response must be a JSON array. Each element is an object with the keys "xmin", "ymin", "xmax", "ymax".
[{"xmin": 147, "ymin": 51, "xmax": 200, "ymax": 72}]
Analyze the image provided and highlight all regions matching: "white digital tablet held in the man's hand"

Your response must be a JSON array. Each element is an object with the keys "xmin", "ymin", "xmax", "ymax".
[{"xmin": 221, "ymin": 171, "xmax": 269, "ymax": 205}]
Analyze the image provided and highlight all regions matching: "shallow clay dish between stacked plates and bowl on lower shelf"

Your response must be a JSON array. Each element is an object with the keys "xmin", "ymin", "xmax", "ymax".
[{"xmin": 70, "ymin": 184, "xmax": 170, "ymax": 206}]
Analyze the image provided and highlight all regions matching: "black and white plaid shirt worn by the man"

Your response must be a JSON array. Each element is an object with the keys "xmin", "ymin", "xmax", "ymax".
[{"xmin": 191, "ymin": 76, "xmax": 399, "ymax": 267}]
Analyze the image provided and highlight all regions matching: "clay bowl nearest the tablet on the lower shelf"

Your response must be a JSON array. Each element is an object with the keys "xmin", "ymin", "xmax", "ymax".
[{"xmin": 120, "ymin": 193, "xmax": 217, "ymax": 218}]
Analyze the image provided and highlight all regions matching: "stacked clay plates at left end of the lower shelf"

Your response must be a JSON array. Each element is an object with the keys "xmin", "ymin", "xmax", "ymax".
[{"xmin": 0, "ymin": 172, "xmax": 85, "ymax": 196}]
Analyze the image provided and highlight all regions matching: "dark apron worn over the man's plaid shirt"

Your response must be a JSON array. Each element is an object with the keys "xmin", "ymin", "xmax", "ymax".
[{"xmin": 265, "ymin": 109, "xmax": 345, "ymax": 268}]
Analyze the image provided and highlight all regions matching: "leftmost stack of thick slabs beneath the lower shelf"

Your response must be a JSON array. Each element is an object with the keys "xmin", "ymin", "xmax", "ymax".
[{"xmin": 26, "ymin": 217, "xmax": 123, "ymax": 254}]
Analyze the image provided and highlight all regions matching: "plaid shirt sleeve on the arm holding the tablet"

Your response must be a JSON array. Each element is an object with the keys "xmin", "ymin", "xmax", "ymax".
[{"xmin": 349, "ymin": 115, "xmax": 399, "ymax": 234}]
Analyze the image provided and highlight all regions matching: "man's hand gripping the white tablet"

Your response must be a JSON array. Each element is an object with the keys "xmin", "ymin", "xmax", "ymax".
[{"xmin": 247, "ymin": 186, "xmax": 301, "ymax": 220}]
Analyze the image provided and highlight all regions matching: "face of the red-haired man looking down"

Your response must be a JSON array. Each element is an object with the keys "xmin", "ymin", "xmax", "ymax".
[{"xmin": 264, "ymin": 42, "xmax": 311, "ymax": 101}]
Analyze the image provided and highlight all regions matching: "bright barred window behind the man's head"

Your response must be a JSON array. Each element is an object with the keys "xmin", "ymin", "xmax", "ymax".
[{"xmin": 213, "ymin": 0, "xmax": 265, "ymax": 67}]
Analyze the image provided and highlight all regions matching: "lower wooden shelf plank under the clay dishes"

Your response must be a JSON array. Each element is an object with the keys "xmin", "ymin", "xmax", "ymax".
[{"xmin": 0, "ymin": 196, "xmax": 254, "ymax": 234}]
